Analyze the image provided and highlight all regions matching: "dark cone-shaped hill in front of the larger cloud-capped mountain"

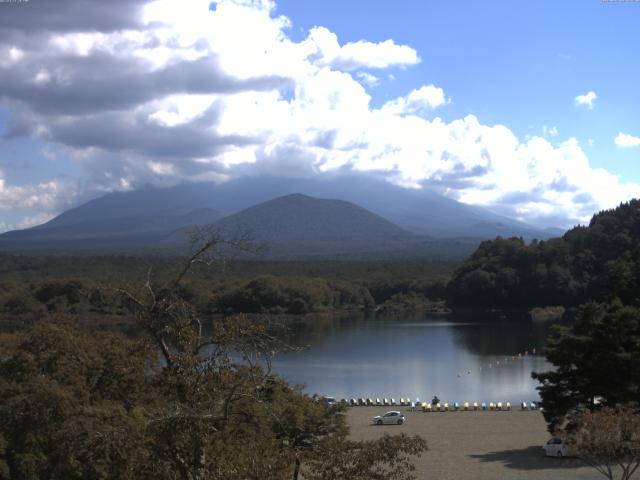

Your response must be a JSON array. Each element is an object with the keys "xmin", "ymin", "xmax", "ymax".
[{"xmin": 164, "ymin": 194, "xmax": 473, "ymax": 258}]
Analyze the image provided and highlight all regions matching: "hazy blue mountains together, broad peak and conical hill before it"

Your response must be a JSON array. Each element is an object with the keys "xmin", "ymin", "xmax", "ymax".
[{"xmin": 0, "ymin": 177, "xmax": 562, "ymax": 258}]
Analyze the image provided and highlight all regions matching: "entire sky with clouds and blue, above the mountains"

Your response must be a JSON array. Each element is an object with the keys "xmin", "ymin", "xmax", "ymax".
[{"xmin": 0, "ymin": 0, "xmax": 640, "ymax": 231}]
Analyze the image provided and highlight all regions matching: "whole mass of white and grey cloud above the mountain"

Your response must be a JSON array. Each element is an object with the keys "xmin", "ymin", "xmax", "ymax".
[{"xmin": 0, "ymin": 0, "xmax": 640, "ymax": 232}]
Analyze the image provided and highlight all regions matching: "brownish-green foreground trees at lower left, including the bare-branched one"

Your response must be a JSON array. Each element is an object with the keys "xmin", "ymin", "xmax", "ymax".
[{"xmin": 0, "ymin": 240, "xmax": 427, "ymax": 480}]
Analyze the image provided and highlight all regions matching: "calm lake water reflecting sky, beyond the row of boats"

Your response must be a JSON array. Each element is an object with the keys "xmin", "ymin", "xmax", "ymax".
[{"xmin": 273, "ymin": 313, "xmax": 550, "ymax": 404}]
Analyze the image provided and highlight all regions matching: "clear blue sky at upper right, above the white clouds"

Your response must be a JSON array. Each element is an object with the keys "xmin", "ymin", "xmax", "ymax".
[{"xmin": 278, "ymin": 0, "xmax": 640, "ymax": 182}]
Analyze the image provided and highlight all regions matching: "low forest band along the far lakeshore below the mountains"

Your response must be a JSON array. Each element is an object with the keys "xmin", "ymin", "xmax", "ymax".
[{"xmin": 0, "ymin": 255, "xmax": 454, "ymax": 320}]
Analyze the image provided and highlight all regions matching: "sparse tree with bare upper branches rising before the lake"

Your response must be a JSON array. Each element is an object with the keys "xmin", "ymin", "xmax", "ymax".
[{"xmin": 120, "ymin": 231, "xmax": 285, "ymax": 480}]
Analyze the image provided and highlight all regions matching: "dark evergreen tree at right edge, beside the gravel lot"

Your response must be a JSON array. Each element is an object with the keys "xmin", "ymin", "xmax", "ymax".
[{"xmin": 533, "ymin": 302, "xmax": 640, "ymax": 431}]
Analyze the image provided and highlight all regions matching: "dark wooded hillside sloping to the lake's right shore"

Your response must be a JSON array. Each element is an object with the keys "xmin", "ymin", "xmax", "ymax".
[{"xmin": 447, "ymin": 200, "xmax": 640, "ymax": 307}]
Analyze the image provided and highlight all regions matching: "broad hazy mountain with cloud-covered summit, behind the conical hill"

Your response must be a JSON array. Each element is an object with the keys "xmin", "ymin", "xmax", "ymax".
[{"xmin": 21, "ymin": 175, "xmax": 552, "ymax": 238}]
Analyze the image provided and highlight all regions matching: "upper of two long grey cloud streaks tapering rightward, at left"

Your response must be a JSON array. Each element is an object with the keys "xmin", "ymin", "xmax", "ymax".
[{"xmin": 0, "ymin": 52, "xmax": 287, "ymax": 115}]
